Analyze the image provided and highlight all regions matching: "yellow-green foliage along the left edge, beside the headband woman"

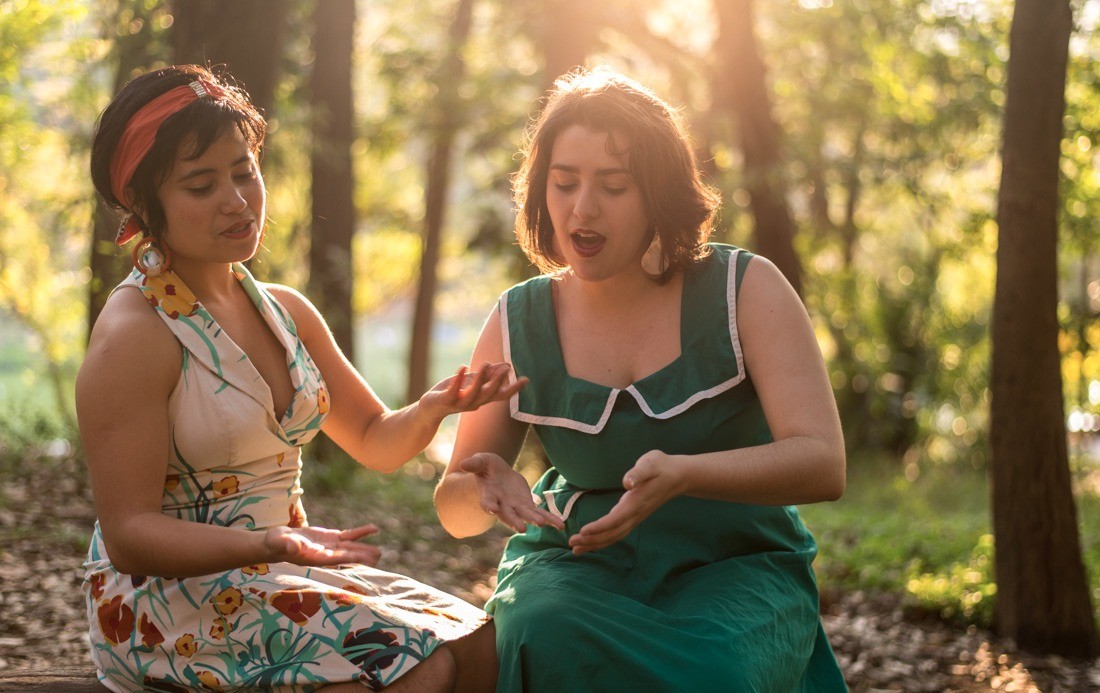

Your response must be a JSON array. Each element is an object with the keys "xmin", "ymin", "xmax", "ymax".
[{"xmin": 0, "ymin": 0, "xmax": 99, "ymax": 435}]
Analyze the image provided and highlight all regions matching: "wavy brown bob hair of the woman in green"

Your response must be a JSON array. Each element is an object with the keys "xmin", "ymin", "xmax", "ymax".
[{"xmin": 513, "ymin": 67, "xmax": 722, "ymax": 283}]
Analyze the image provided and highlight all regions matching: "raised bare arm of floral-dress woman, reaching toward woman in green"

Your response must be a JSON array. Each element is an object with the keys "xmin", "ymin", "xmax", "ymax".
[{"xmin": 267, "ymin": 285, "xmax": 523, "ymax": 473}]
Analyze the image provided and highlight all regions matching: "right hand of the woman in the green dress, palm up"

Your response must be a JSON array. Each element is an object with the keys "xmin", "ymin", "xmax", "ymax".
[{"xmin": 569, "ymin": 450, "xmax": 686, "ymax": 556}]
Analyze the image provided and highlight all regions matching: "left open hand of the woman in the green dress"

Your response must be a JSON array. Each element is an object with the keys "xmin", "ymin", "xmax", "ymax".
[{"xmin": 459, "ymin": 452, "xmax": 565, "ymax": 532}]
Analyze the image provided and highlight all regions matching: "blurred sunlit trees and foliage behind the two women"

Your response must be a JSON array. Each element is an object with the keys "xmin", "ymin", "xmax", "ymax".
[{"xmin": 0, "ymin": 0, "xmax": 1100, "ymax": 655}]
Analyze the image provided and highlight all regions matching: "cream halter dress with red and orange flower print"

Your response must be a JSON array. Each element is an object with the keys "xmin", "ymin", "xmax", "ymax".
[{"xmin": 84, "ymin": 265, "xmax": 488, "ymax": 692}]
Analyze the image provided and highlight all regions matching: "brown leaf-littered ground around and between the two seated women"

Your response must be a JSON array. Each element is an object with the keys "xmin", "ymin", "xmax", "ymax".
[{"xmin": 0, "ymin": 458, "xmax": 1100, "ymax": 693}]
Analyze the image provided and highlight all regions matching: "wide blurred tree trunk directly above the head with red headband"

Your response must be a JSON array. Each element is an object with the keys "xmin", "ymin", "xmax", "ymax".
[{"xmin": 169, "ymin": 0, "xmax": 288, "ymax": 116}]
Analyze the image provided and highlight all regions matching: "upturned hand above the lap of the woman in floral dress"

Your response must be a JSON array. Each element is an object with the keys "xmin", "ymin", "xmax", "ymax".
[{"xmin": 264, "ymin": 525, "xmax": 382, "ymax": 567}]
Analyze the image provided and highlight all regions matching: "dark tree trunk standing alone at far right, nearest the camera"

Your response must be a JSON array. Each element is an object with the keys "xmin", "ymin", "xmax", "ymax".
[{"xmin": 990, "ymin": 0, "xmax": 1097, "ymax": 656}]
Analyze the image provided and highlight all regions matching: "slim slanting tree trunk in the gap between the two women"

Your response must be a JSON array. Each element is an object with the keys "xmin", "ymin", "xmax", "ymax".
[{"xmin": 405, "ymin": 0, "xmax": 474, "ymax": 402}]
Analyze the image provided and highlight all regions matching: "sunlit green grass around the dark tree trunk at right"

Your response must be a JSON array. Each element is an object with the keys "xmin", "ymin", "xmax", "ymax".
[{"xmin": 800, "ymin": 460, "xmax": 1100, "ymax": 627}]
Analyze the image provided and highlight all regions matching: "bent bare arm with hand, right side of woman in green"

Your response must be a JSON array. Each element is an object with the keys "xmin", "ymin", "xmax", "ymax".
[{"xmin": 571, "ymin": 257, "xmax": 845, "ymax": 552}]
